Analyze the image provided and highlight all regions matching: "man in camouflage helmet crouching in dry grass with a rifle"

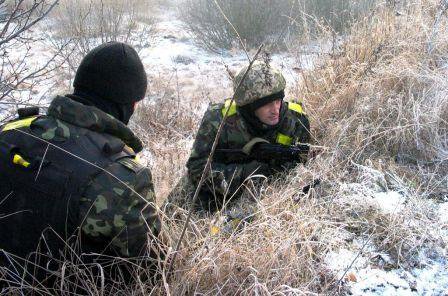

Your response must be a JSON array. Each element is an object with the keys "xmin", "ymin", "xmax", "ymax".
[{"xmin": 168, "ymin": 61, "xmax": 310, "ymax": 211}]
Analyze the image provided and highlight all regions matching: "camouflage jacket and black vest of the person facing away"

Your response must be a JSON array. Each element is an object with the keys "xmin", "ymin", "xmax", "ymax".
[{"xmin": 0, "ymin": 96, "xmax": 160, "ymax": 282}]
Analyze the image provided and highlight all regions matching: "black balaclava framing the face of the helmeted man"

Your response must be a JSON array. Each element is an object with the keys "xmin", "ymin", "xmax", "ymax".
[{"xmin": 238, "ymin": 91, "xmax": 285, "ymax": 136}]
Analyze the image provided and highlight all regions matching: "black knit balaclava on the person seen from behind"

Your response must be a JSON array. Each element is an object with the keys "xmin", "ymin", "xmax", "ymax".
[{"xmin": 68, "ymin": 42, "xmax": 148, "ymax": 124}]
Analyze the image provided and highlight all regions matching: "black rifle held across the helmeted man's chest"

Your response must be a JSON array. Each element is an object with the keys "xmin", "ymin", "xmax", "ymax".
[{"xmin": 214, "ymin": 143, "xmax": 310, "ymax": 164}]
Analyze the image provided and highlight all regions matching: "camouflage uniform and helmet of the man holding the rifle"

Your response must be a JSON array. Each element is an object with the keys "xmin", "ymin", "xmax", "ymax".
[{"xmin": 169, "ymin": 62, "xmax": 310, "ymax": 211}]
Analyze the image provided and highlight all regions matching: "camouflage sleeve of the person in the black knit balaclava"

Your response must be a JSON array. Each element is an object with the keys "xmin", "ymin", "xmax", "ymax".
[{"xmin": 80, "ymin": 158, "xmax": 161, "ymax": 257}]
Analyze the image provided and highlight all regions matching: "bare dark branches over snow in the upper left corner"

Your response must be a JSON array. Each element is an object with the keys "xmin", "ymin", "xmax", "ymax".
[{"xmin": 0, "ymin": 0, "xmax": 60, "ymax": 123}]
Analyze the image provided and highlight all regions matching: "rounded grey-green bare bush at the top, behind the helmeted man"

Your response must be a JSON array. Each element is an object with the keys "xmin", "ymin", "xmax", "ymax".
[{"xmin": 181, "ymin": 0, "xmax": 298, "ymax": 51}]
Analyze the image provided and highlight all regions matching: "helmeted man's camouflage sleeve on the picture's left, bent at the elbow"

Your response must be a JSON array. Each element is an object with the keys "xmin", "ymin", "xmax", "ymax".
[{"xmin": 187, "ymin": 108, "xmax": 267, "ymax": 194}]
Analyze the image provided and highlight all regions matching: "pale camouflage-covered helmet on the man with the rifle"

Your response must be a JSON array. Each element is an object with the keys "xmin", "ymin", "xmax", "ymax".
[{"xmin": 233, "ymin": 61, "xmax": 286, "ymax": 107}]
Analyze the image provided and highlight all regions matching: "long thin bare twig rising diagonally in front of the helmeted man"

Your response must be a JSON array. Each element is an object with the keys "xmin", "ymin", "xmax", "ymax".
[{"xmin": 168, "ymin": 44, "xmax": 263, "ymax": 276}]
